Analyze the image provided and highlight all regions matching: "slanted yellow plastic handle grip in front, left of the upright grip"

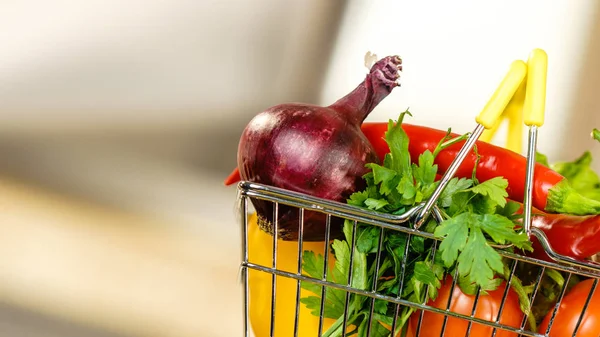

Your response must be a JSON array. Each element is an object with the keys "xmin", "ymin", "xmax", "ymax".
[{"xmin": 475, "ymin": 60, "xmax": 527, "ymax": 129}]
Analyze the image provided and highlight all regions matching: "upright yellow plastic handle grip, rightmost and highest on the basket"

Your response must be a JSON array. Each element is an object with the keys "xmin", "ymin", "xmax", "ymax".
[{"xmin": 523, "ymin": 48, "xmax": 548, "ymax": 126}]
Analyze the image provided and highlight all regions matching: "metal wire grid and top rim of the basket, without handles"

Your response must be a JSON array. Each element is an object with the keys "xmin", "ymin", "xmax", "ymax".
[{"xmin": 238, "ymin": 182, "xmax": 600, "ymax": 337}]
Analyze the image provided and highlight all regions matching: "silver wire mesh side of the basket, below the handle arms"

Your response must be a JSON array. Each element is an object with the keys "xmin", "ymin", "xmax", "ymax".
[{"xmin": 239, "ymin": 183, "xmax": 599, "ymax": 337}]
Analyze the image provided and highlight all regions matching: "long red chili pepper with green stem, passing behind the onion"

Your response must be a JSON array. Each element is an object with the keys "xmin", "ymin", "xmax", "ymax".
[{"xmin": 225, "ymin": 122, "xmax": 600, "ymax": 215}]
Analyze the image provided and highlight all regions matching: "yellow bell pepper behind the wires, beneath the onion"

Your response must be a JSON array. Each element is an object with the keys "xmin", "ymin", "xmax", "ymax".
[{"xmin": 248, "ymin": 214, "xmax": 335, "ymax": 337}]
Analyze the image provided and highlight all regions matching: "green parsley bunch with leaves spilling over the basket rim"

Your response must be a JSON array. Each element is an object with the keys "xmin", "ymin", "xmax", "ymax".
[{"xmin": 302, "ymin": 110, "xmax": 531, "ymax": 337}]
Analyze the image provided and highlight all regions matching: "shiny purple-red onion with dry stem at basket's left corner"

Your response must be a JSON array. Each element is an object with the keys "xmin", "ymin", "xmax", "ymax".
[{"xmin": 237, "ymin": 56, "xmax": 402, "ymax": 241}]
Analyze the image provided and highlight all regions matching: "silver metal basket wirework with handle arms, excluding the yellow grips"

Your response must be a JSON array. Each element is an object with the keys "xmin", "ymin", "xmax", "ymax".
[{"xmin": 233, "ymin": 49, "xmax": 600, "ymax": 337}]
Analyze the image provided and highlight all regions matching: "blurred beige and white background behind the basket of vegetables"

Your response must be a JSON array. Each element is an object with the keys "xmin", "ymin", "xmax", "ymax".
[{"xmin": 0, "ymin": 0, "xmax": 600, "ymax": 337}]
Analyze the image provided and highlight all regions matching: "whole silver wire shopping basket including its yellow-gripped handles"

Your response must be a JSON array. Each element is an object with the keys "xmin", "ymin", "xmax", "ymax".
[{"xmin": 233, "ymin": 49, "xmax": 600, "ymax": 337}]
